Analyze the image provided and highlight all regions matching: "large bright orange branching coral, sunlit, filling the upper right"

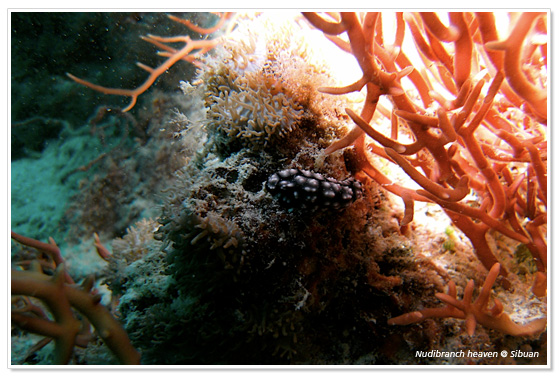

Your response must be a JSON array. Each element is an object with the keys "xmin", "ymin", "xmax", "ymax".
[{"xmin": 304, "ymin": 12, "xmax": 547, "ymax": 296}]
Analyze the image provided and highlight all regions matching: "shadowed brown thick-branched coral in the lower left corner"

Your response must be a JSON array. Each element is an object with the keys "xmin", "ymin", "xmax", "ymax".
[{"xmin": 11, "ymin": 232, "xmax": 140, "ymax": 364}]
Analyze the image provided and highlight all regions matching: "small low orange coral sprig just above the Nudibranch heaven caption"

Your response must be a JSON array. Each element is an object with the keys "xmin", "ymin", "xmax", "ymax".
[{"xmin": 388, "ymin": 263, "xmax": 546, "ymax": 336}]
